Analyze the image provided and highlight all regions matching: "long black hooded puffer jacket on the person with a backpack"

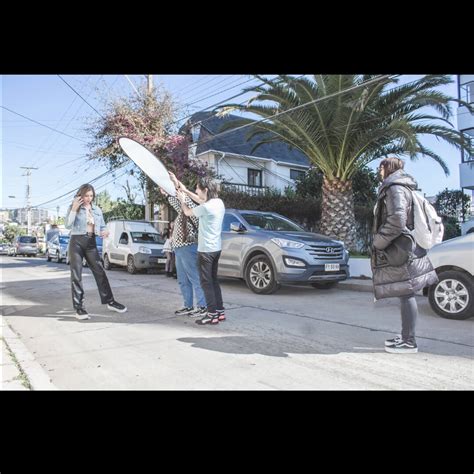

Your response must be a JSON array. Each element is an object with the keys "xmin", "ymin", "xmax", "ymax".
[{"xmin": 372, "ymin": 170, "xmax": 438, "ymax": 300}]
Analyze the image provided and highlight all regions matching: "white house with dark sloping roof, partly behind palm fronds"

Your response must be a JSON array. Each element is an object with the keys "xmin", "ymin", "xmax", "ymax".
[{"xmin": 184, "ymin": 112, "xmax": 309, "ymax": 194}]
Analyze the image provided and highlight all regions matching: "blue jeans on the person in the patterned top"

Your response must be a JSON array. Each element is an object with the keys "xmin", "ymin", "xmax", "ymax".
[{"xmin": 174, "ymin": 244, "xmax": 206, "ymax": 308}]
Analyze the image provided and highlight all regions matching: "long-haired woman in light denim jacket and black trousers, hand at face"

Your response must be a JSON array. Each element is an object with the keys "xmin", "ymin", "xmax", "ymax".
[{"xmin": 66, "ymin": 184, "xmax": 127, "ymax": 319}]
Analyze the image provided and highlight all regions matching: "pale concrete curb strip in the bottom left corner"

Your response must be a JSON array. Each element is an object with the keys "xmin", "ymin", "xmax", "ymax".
[{"xmin": 2, "ymin": 319, "xmax": 57, "ymax": 390}]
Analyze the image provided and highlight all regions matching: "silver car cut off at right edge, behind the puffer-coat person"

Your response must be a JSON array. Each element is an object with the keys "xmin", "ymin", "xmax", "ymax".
[{"xmin": 424, "ymin": 233, "xmax": 474, "ymax": 319}]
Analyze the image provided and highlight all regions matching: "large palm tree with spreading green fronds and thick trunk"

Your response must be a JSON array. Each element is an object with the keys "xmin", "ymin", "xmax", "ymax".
[{"xmin": 216, "ymin": 75, "xmax": 470, "ymax": 249}]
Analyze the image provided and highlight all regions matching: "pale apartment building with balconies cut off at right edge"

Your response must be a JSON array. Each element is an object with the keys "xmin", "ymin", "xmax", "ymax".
[{"xmin": 458, "ymin": 74, "xmax": 474, "ymax": 234}]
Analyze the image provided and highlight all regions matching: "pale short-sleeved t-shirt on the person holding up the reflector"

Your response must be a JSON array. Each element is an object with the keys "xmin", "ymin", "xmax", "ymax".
[{"xmin": 192, "ymin": 198, "xmax": 225, "ymax": 252}]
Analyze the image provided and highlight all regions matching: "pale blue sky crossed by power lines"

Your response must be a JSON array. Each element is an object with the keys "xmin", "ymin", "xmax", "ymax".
[{"xmin": 0, "ymin": 74, "xmax": 461, "ymax": 220}]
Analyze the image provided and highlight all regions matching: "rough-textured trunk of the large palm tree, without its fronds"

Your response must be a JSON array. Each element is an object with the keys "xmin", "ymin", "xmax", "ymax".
[{"xmin": 319, "ymin": 177, "xmax": 356, "ymax": 250}]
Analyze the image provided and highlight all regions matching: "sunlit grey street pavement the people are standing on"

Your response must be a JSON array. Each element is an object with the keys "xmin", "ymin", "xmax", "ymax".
[{"xmin": 0, "ymin": 256, "xmax": 474, "ymax": 390}]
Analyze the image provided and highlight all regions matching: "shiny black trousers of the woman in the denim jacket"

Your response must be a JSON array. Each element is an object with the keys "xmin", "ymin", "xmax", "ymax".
[{"xmin": 68, "ymin": 234, "xmax": 114, "ymax": 310}]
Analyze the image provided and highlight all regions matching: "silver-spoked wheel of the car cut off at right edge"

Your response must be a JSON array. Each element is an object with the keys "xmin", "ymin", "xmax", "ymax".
[{"xmin": 428, "ymin": 270, "xmax": 474, "ymax": 319}]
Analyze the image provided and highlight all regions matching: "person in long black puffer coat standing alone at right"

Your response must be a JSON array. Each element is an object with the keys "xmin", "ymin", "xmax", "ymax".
[{"xmin": 371, "ymin": 158, "xmax": 438, "ymax": 353}]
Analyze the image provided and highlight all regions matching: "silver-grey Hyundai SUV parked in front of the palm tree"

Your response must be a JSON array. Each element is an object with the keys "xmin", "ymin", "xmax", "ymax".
[{"xmin": 218, "ymin": 209, "xmax": 349, "ymax": 294}]
